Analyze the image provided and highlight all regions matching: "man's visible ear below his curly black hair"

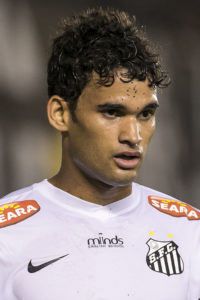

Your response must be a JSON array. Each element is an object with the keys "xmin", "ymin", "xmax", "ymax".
[{"xmin": 47, "ymin": 95, "xmax": 70, "ymax": 132}]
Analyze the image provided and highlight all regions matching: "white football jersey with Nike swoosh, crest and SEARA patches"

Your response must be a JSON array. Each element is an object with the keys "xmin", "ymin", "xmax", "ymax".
[{"xmin": 0, "ymin": 180, "xmax": 200, "ymax": 300}]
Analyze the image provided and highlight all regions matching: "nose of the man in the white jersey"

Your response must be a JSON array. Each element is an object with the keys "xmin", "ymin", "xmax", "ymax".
[{"xmin": 119, "ymin": 117, "xmax": 142, "ymax": 147}]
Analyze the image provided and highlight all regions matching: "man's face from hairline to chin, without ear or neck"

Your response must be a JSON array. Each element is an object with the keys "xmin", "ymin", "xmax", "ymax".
[{"xmin": 64, "ymin": 75, "xmax": 158, "ymax": 186}]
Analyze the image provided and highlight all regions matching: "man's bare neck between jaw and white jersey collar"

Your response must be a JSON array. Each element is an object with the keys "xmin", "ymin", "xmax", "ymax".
[{"xmin": 49, "ymin": 168, "xmax": 132, "ymax": 205}]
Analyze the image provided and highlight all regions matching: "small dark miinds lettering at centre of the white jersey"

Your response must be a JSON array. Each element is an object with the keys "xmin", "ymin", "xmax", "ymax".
[{"xmin": 87, "ymin": 233, "xmax": 124, "ymax": 248}]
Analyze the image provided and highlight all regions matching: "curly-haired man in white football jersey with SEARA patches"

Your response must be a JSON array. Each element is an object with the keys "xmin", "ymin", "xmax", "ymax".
[{"xmin": 0, "ymin": 9, "xmax": 200, "ymax": 300}]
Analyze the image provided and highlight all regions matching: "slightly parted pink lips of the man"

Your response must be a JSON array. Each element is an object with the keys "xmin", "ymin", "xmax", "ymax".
[{"xmin": 113, "ymin": 151, "xmax": 141, "ymax": 169}]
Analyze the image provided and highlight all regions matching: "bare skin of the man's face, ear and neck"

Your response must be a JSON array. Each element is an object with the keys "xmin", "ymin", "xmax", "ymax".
[{"xmin": 48, "ymin": 75, "xmax": 158, "ymax": 205}]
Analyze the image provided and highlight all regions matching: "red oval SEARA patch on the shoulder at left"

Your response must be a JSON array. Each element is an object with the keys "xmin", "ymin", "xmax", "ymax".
[{"xmin": 0, "ymin": 200, "xmax": 40, "ymax": 228}]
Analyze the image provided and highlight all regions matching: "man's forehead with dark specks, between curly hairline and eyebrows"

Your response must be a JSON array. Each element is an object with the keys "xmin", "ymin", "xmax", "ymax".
[{"xmin": 79, "ymin": 71, "xmax": 157, "ymax": 106}]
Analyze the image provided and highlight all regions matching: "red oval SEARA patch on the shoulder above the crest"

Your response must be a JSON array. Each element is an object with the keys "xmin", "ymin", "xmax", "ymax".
[{"xmin": 148, "ymin": 196, "xmax": 200, "ymax": 220}]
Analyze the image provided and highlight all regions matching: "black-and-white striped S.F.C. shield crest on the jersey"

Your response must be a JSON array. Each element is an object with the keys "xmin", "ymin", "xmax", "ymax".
[{"xmin": 146, "ymin": 239, "xmax": 184, "ymax": 276}]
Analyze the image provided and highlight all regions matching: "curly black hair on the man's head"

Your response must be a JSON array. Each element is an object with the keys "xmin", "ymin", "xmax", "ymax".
[{"xmin": 48, "ymin": 8, "xmax": 169, "ymax": 113}]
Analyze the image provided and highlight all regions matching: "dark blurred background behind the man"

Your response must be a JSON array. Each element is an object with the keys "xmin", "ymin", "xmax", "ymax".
[{"xmin": 0, "ymin": 0, "xmax": 200, "ymax": 208}]
